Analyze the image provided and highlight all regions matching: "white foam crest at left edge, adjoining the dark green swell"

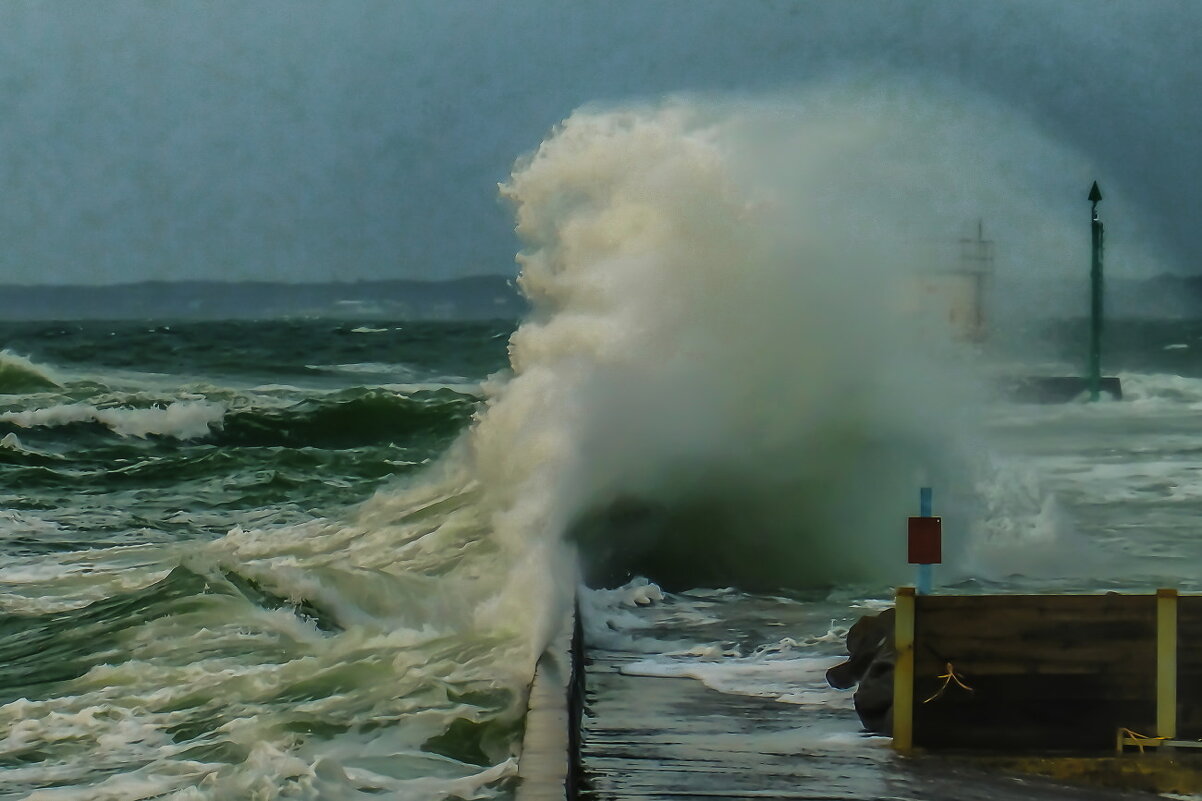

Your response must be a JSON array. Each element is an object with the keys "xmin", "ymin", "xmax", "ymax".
[{"xmin": 0, "ymin": 401, "xmax": 226, "ymax": 439}]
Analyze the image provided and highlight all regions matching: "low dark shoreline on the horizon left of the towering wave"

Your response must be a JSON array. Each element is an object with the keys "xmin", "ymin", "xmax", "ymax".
[{"xmin": 0, "ymin": 275, "xmax": 526, "ymax": 320}]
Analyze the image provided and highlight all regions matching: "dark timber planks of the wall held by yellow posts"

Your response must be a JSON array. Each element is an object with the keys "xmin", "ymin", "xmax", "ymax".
[{"xmin": 914, "ymin": 594, "xmax": 1153, "ymax": 752}]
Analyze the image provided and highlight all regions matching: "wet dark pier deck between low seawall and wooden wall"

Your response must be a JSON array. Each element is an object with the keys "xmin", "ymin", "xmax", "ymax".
[{"xmin": 579, "ymin": 606, "xmax": 1155, "ymax": 801}]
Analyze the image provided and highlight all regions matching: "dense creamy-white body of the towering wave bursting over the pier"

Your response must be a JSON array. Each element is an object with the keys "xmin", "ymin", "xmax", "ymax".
[{"xmin": 488, "ymin": 95, "xmax": 963, "ymax": 586}]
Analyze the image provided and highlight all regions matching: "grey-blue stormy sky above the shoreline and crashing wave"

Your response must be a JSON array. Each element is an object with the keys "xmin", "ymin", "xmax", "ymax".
[{"xmin": 0, "ymin": 0, "xmax": 1202, "ymax": 284}]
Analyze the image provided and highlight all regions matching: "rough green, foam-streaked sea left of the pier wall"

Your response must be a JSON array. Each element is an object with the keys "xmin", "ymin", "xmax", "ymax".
[{"xmin": 0, "ymin": 322, "xmax": 529, "ymax": 800}]
